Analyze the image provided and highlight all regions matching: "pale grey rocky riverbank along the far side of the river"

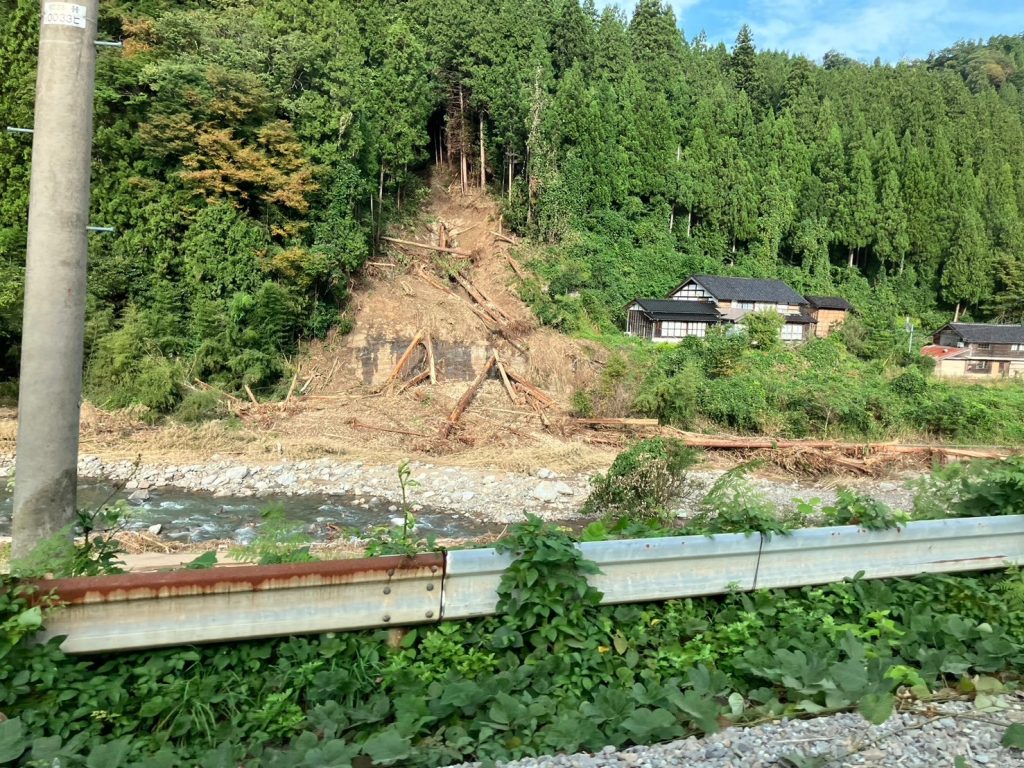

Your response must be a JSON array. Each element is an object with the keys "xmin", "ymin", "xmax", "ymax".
[{"xmin": 0, "ymin": 455, "xmax": 911, "ymax": 523}]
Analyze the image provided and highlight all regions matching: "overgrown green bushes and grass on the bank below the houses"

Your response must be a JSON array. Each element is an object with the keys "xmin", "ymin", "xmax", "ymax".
[{"xmin": 577, "ymin": 331, "xmax": 1024, "ymax": 443}]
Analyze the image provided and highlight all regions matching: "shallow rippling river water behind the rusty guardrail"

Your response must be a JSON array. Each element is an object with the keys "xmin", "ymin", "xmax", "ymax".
[{"xmin": 0, "ymin": 480, "xmax": 503, "ymax": 544}]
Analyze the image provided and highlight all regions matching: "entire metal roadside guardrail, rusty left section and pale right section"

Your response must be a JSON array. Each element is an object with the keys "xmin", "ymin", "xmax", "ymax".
[{"xmin": 32, "ymin": 515, "xmax": 1024, "ymax": 653}]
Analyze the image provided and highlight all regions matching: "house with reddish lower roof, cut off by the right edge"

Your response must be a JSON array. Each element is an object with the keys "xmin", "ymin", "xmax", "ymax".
[{"xmin": 921, "ymin": 323, "xmax": 1024, "ymax": 380}]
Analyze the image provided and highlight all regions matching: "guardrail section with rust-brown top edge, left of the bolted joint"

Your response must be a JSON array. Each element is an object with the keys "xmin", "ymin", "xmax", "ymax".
[{"xmin": 38, "ymin": 554, "xmax": 444, "ymax": 653}]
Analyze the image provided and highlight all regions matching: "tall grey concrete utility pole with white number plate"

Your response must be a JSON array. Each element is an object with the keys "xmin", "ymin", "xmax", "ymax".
[{"xmin": 11, "ymin": 0, "xmax": 98, "ymax": 559}]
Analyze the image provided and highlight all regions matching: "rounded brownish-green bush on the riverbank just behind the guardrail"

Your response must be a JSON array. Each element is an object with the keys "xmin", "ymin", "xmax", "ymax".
[{"xmin": 581, "ymin": 437, "xmax": 700, "ymax": 519}]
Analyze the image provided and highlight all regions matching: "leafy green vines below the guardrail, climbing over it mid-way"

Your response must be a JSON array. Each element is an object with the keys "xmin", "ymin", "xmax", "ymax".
[{"xmin": 6, "ymin": 499, "xmax": 1024, "ymax": 768}]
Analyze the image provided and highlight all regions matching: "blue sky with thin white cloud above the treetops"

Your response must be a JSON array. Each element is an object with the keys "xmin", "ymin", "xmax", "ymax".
[{"xmin": 604, "ymin": 0, "xmax": 1024, "ymax": 62}]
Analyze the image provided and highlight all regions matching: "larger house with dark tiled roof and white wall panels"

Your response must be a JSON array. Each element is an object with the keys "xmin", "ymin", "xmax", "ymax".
[{"xmin": 626, "ymin": 274, "xmax": 850, "ymax": 342}]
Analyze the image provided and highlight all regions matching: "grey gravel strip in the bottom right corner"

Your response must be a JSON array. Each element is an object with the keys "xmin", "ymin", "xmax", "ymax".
[{"xmin": 446, "ymin": 695, "xmax": 1024, "ymax": 768}]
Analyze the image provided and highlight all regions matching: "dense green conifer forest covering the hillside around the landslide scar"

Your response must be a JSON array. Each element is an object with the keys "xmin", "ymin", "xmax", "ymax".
[{"xmin": 0, "ymin": 0, "xmax": 1024, "ymax": 411}]
